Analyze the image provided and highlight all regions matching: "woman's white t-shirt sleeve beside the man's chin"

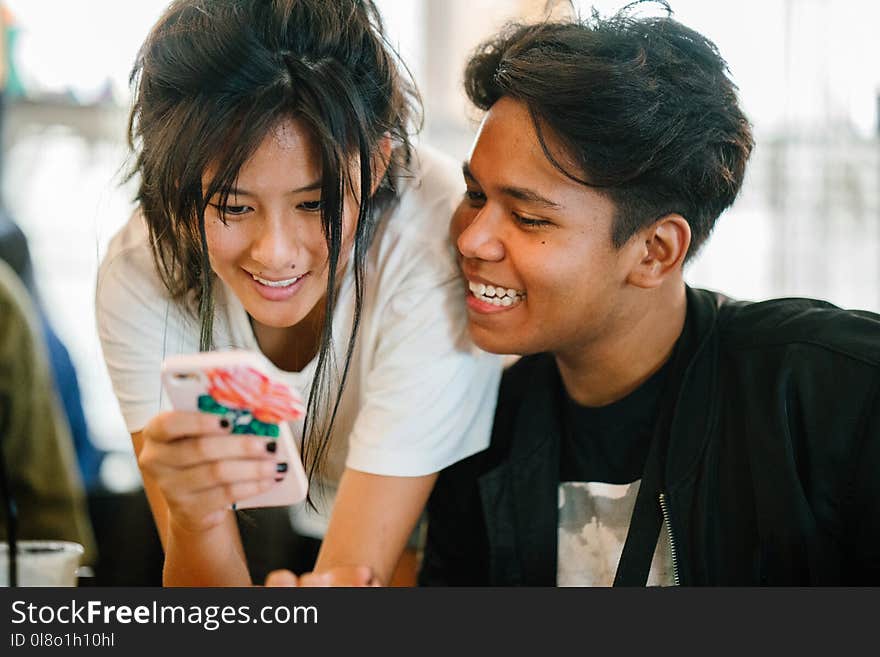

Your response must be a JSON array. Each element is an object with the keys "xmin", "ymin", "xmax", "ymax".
[{"xmin": 346, "ymin": 246, "xmax": 501, "ymax": 476}]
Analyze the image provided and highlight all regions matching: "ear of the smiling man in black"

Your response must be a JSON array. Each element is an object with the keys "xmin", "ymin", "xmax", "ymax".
[{"xmin": 627, "ymin": 214, "xmax": 691, "ymax": 289}]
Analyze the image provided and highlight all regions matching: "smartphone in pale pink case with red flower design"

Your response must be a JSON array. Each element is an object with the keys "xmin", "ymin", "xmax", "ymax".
[{"xmin": 162, "ymin": 349, "xmax": 308, "ymax": 509}]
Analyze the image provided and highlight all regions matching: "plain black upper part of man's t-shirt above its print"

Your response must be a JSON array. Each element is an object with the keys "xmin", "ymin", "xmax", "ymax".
[{"xmin": 559, "ymin": 361, "xmax": 669, "ymax": 484}]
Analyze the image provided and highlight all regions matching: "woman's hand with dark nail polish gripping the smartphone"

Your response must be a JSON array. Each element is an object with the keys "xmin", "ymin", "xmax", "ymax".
[{"xmin": 138, "ymin": 411, "xmax": 284, "ymax": 533}]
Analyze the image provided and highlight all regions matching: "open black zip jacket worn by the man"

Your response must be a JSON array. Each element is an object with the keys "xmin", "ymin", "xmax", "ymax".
[{"xmin": 419, "ymin": 289, "xmax": 880, "ymax": 586}]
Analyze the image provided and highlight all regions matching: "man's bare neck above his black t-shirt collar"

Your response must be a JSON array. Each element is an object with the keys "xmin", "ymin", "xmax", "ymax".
[{"xmin": 555, "ymin": 279, "xmax": 687, "ymax": 406}]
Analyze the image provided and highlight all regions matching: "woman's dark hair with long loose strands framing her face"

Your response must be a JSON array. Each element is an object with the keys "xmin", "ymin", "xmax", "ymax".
[{"xmin": 129, "ymin": 0, "xmax": 418, "ymax": 492}]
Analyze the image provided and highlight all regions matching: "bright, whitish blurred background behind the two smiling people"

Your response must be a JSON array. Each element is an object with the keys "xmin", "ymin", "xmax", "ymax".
[{"xmin": 0, "ymin": 0, "xmax": 880, "ymax": 584}]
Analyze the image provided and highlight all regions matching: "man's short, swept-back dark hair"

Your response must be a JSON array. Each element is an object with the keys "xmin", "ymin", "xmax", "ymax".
[{"xmin": 465, "ymin": 3, "xmax": 754, "ymax": 257}]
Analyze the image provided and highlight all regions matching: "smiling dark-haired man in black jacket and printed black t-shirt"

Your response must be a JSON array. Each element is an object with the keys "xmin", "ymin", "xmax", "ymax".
[{"xmin": 420, "ymin": 9, "xmax": 880, "ymax": 586}]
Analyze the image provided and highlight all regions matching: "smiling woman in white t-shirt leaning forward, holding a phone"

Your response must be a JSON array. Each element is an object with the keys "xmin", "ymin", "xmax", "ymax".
[{"xmin": 97, "ymin": 0, "xmax": 500, "ymax": 585}]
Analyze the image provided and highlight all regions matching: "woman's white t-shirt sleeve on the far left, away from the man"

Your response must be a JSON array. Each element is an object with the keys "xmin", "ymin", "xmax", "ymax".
[{"xmin": 95, "ymin": 226, "xmax": 197, "ymax": 433}]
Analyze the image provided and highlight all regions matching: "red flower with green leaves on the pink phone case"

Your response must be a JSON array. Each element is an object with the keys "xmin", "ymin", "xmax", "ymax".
[{"xmin": 198, "ymin": 366, "xmax": 305, "ymax": 438}]
